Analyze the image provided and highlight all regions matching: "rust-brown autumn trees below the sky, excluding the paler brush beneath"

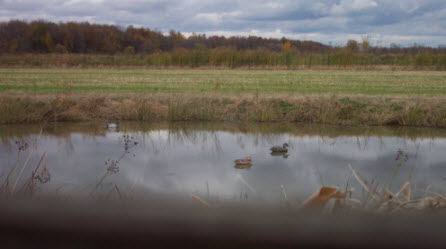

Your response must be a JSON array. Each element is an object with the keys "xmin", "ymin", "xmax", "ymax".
[{"xmin": 0, "ymin": 20, "xmax": 446, "ymax": 55}]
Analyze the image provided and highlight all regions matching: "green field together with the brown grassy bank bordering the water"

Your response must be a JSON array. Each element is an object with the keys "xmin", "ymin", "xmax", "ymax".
[{"xmin": 0, "ymin": 68, "xmax": 446, "ymax": 127}]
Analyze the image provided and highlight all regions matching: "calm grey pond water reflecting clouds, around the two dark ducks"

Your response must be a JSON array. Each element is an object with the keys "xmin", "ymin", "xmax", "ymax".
[{"xmin": 0, "ymin": 122, "xmax": 446, "ymax": 201}]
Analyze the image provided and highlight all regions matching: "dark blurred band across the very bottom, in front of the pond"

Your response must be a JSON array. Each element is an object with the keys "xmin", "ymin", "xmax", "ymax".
[{"xmin": 0, "ymin": 198, "xmax": 446, "ymax": 249}]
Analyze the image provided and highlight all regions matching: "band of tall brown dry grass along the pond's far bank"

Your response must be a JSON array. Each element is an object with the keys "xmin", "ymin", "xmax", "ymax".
[{"xmin": 0, "ymin": 94, "xmax": 446, "ymax": 127}]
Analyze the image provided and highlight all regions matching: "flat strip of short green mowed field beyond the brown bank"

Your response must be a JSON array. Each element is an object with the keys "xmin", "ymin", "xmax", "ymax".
[{"xmin": 0, "ymin": 68, "xmax": 446, "ymax": 96}]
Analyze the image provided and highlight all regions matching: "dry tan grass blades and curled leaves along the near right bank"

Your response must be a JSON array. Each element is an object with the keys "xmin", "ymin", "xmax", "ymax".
[{"xmin": 191, "ymin": 165, "xmax": 446, "ymax": 215}]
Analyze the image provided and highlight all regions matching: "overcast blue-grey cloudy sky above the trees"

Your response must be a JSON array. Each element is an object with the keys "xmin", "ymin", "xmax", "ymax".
[{"xmin": 0, "ymin": 0, "xmax": 446, "ymax": 47}]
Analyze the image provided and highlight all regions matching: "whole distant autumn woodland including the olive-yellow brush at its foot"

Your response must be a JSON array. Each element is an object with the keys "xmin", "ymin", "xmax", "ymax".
[{"xmin": 0, "ymin": 20, "xmax": 446, "ymax": 69}]
